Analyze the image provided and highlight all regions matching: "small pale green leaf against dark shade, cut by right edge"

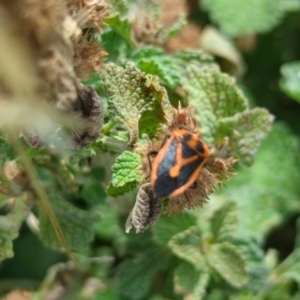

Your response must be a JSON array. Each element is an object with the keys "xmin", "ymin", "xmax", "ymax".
[{"xmin": 279, "ymin": 61, "xmax": 300, "ymax": 102}]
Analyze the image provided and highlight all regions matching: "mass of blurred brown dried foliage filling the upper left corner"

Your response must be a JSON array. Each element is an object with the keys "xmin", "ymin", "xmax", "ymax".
[{"xmin": 0, "ymin": 0, "xmax": 107, "ymax": 148}]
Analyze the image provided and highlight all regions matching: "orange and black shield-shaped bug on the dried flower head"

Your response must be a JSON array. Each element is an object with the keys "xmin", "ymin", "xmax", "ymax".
[{"xmin": 148, "ymin": 128, "xmax": 209, "ymax": 197}]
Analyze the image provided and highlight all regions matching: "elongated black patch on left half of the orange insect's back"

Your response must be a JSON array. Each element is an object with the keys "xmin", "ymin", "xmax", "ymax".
[{"xmin": 154, "ymin": 140, "xmax": 178, "ymax": 197}]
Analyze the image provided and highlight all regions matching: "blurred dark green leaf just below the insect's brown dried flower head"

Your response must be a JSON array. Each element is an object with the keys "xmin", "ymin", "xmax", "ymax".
[{"xmin": 152, "ymin": 213, "xmax": 196, "ymax": 245}]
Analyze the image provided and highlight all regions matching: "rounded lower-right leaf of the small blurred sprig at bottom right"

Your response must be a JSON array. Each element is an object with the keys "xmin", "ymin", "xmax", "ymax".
[{"xmin": 206, "ymin": 242, "xmax": 249, "ymax": 287}]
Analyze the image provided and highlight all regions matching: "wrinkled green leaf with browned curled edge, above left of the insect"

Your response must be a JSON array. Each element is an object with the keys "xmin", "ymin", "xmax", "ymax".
[{"xmin": 103, "ymin": 63, "xmax": 172, "ymax": 145}]
